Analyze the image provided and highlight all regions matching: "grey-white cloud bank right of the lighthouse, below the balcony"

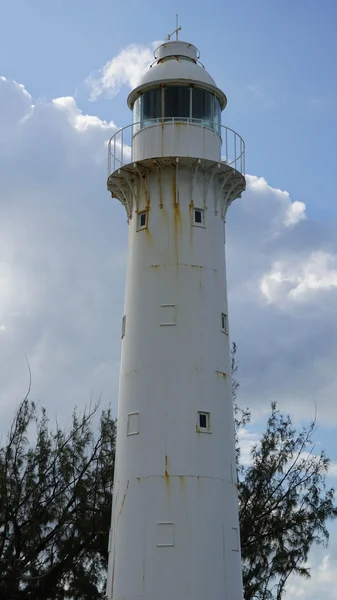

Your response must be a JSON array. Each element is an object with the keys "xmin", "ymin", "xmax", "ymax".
[{"xmin": 226, "ymin": 176, "xmax": 337, "ymax": 423}]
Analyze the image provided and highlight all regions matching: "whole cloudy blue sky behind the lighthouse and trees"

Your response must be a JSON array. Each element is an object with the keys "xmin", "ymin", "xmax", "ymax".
[{"xmin": 0, "ymin": 0, "xmax": 337, "ymax": 600}]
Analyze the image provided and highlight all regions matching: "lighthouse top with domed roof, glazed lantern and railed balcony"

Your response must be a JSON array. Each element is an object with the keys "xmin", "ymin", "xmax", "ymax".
[{"xmin": 108, "ymin": 39, "xmax": 244, "ymax": 185}]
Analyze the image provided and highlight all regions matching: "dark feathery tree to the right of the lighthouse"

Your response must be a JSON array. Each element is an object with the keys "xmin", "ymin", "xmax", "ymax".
[{"xmin": 232, "ymin": 345, "xmax": 337, "ymax": 600}]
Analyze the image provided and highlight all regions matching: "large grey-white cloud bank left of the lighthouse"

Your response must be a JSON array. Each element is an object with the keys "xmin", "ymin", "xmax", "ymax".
[{"xmin": 0, "ymin": 79, "xmax": 127, "ymax": 426}]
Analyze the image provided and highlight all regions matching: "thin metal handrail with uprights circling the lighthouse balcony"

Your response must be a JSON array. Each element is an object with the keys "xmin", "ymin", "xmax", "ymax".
[{"xmin": 108, "ymin": 117, "xmax": 245, "ymax": 177}]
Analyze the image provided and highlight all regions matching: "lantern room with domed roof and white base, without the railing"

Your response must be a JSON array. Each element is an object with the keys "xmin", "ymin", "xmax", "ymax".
[{"xmin": 123, "ymin": 40, "xmax": 227, "ymax": 160}]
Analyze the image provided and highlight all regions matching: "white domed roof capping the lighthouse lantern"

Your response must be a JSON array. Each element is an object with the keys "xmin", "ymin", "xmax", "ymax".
[{"xmin": 128, "ymin": 40, "xmax": 227, "ymax": 110}]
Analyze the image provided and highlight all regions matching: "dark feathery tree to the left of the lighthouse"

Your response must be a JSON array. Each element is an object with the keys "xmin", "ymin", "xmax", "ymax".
[{"xmin": 0, "ymin": 386, "xmax": 115, "ymax": 600}]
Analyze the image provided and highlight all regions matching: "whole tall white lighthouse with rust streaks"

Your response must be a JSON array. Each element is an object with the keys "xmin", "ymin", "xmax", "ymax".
[{"xmin": 107, "ymin": 27, "xmax": 245, "ymax": 600}]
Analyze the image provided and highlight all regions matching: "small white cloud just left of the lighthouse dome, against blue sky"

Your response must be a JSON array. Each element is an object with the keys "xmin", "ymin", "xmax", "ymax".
[{"xmin": 86, "ymin": 42, "xmax": 160, "ymax": 100}]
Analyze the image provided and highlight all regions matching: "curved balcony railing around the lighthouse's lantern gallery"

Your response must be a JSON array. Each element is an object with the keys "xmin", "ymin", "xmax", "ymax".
[{"xmin": 108, "ymin": 117, "xmax": 245, "ymax": 176}]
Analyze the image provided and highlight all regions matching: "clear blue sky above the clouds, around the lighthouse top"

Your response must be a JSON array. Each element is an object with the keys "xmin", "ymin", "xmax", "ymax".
[{"xmin": 0, "ymin": 0, "xmax": 337, "ymax": 219}]
